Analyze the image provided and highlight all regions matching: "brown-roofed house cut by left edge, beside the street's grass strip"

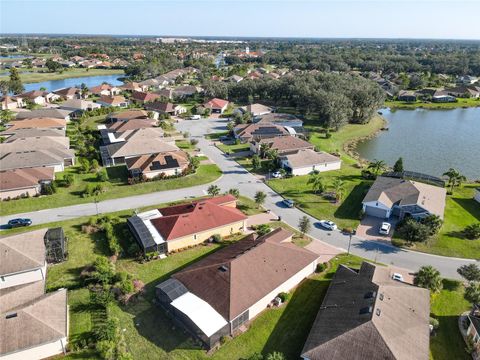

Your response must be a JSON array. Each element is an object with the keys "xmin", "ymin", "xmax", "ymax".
[{"xmin": 0, "ymin": 167, "xmax": 55, "ymax": 200}]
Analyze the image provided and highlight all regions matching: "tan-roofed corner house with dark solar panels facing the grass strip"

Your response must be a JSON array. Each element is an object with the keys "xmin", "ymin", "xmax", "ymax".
[{"xmin": 125, "ymin": 150, "xmax": 189, "ymax": 179}]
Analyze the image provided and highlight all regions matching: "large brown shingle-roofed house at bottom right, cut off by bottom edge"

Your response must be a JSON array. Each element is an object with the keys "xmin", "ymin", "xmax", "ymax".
[{"xmin": 301, "ymin": 262, "xmax": 430, "ymax": 360}]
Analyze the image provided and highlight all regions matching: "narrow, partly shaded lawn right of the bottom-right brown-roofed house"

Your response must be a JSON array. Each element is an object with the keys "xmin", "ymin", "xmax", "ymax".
[{"xmin": 430, "ymin": 280, "xmax": 471, "ymax": 360}]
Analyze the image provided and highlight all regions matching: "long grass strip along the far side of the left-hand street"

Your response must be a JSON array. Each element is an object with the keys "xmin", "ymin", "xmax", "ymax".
[{"xmin": 0, "ymin": 164, "xmax": 222, "ymax": 215}]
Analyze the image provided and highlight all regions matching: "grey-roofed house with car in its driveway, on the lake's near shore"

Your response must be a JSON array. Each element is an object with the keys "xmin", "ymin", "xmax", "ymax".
[{"xmin": 362, "ymin": 176, "xmax": 447, "ymax": 219}]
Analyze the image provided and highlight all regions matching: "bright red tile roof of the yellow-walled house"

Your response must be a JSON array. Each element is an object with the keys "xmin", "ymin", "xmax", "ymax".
[{"xmin": 151, "ymin": 195, "xmax": 247, "ymax": 240}]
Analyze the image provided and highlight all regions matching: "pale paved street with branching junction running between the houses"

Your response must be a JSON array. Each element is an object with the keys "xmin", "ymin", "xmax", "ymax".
[{"xmin": 0, "ymin": 119, "xmax": 475, "ymax": 278}]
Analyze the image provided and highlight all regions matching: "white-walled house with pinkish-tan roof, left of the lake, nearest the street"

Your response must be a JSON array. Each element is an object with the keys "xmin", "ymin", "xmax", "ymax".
[{"xmin": 280, "ymin": 149, "xmax": 342, "ymax": 175}]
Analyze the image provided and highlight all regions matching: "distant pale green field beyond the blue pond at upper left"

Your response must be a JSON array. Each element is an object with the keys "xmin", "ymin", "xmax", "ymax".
[{"xmin": 0, "ymin": 68, "xmax": 124, "ymax": 83}]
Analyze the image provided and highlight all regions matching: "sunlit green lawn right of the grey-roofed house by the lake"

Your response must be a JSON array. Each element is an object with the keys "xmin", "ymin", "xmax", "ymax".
[{"xmin": 396, "ymin": 184, "xmax": 480, "ymax": 259}]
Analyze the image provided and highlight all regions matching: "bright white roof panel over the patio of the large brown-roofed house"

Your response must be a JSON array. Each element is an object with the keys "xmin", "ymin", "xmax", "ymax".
[{"xmin": 171, "ymin": 292, "xmax": 228, "ymax": 337}]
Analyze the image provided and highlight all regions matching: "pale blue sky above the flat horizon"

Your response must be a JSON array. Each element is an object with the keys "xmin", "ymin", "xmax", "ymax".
[{"xmin": 0, "ymin": 0, "xmax": 480, "ymax": 39}]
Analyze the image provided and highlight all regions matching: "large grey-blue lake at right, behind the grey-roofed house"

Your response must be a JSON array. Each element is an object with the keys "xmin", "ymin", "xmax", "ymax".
[{"xmin": 357, "ymin": 108, "xmax": 480, "ymax": 179}]
